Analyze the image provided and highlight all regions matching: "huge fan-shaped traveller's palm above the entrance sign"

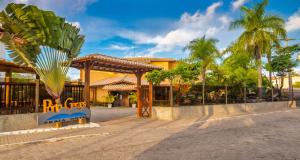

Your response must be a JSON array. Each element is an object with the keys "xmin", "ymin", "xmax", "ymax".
[{"xmin": 0, "ymin": 3, "xmax": 84, "ymax": 104}]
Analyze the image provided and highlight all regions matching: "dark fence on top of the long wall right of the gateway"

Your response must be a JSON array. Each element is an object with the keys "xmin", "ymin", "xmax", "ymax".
[{"xmin": 153, "ymin": 84, "xmax": 294, "ymax": 106}]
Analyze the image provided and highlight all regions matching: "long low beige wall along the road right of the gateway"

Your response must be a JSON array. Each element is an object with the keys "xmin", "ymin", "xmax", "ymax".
[{"xmin": 152, "ymin": 101, "xmax": 296, "ymax": 120}]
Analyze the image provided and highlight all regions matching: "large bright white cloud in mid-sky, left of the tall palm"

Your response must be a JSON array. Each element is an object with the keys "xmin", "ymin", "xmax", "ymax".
[{"xmin": 120, "ymin": 2, "xmax": 230, "ymax": 56}]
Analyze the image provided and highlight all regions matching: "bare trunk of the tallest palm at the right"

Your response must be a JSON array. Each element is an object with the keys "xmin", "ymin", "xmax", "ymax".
[{"xmin": 255, "ymin": 46, "xmax": 263, "ymax": 101}]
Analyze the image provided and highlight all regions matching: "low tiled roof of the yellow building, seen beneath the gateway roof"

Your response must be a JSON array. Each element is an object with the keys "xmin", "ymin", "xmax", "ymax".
[{"xmin": 91, "ymin": 75, "xmax": 148, "ymax": 86}]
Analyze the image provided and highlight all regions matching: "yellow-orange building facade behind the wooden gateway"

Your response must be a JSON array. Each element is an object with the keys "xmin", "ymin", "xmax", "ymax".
[{"xmin": 80, "ymin": 57, "xmax": 177, "ymax": 107}]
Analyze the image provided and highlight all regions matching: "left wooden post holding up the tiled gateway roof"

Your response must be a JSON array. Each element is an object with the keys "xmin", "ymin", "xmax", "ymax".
[{"xmin": 84, "ymin": 61, "xmax": 91, "ymax": 108}]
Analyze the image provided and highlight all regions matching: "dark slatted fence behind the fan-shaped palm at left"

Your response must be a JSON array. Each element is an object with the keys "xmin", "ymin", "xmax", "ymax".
[{"xmin": 0, "ymin": 82, "xmax": 84, "ymax": 115}]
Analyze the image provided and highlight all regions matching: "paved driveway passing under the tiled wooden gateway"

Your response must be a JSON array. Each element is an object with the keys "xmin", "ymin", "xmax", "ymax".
[{"xmin": 91, "ymin": 107, "xmax": 136, "ymax": 122}]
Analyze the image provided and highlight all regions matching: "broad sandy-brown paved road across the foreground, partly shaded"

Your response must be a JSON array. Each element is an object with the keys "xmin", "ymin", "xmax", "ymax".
[{"xmin": 0, "ymin": 110, "xmax": 300, "ymax": 160}]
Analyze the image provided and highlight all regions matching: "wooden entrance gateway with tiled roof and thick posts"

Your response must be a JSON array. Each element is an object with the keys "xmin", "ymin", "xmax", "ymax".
[{"xmin": 71, "ymin": 54, "xmax": 161, "ymax": 117}]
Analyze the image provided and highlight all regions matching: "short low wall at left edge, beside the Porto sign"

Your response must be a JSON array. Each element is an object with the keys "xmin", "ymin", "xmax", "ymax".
[{"xmin": 0, "ymin": 113, "xmax": 38, "ymax": 132}]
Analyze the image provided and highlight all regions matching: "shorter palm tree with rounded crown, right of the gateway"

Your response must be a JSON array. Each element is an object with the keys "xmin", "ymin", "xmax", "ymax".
[{"xmin": 185, "ymin": 36, "xmax": 219, "ymax": 104}]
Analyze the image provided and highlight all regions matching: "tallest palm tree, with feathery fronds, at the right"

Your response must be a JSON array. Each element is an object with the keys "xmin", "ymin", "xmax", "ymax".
[{"xmin": 230, "ymin": 0, "xmax": 286, "ymax": 99}]
